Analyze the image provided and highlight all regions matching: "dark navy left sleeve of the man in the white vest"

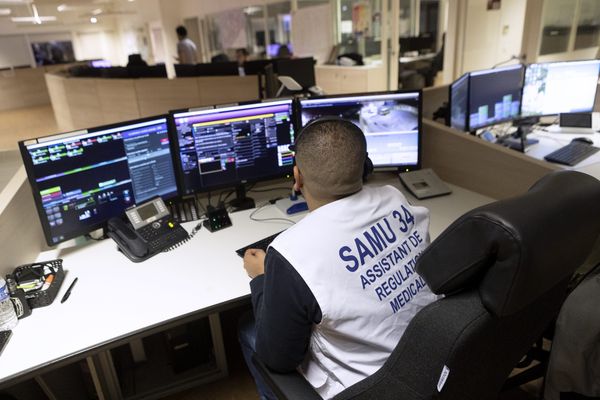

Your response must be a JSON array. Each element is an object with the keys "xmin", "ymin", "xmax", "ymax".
[{"xmin": 250, "ymin": 248, "xmax": 322, "ymax": 372}]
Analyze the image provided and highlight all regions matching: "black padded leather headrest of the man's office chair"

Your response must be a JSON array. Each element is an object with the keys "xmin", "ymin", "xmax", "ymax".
[{"xmin": 416, "ymin": 171, "xmax": 600, "ymax": 316}]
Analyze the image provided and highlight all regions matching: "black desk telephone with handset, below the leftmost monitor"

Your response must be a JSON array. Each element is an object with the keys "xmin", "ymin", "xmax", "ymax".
[{"xmin": 107, "ymin": 197, "xmax": 189, "ymax": 262}]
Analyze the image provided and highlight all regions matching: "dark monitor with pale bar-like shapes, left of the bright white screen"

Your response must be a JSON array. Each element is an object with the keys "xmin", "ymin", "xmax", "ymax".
[{"xmin": 467, "ymin": 64, "xmax": 523, "ymax": 131}]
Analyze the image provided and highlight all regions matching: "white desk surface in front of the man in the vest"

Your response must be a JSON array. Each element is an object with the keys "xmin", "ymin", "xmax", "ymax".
[{"xmin": 0, "ymin": 173, "xmax": 493, "ymax": 385}]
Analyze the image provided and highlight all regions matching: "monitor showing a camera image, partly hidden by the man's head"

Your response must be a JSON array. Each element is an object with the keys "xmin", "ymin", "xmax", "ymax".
[{"xmin": 297, "ymin": 91, "xmax": 422, "ymax": 171}]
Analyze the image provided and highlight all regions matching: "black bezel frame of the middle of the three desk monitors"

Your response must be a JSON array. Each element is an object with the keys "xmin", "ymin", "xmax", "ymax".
[{"xmin": 168, "ymin": 98, "xmax": 297, "ymax": 196}]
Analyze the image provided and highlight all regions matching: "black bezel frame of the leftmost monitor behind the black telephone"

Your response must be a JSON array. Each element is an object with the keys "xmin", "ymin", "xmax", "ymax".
[{"xmin": 18, "ymin": 114, "xmax": 179, "ymax": 247}]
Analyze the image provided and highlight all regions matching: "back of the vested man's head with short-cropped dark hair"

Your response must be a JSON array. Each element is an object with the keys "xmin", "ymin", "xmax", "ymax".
[{"xmin": 296, "ymin": 119, "xmax": 367, "ymax": 198}]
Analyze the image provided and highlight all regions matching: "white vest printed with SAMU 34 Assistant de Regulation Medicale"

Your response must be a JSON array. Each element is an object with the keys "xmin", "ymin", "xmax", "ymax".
[{"xmin": 271, "ymin": 186, "xmax": 437, "ymax": 399}]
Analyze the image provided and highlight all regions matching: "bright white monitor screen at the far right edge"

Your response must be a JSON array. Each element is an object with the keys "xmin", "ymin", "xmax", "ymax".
[{"xmin": 521, "ymin": 60, "xmax": 600, "ymax": 117}]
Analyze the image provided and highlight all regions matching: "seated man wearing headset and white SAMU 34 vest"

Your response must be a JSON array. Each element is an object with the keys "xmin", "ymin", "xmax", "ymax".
[{"xmin": 240, "ymin": 118, "xmax": 436, "ymax": 399}]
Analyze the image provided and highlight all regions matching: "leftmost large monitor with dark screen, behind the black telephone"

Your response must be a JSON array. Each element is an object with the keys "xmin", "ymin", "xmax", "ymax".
[{"xmin": 19, "ymin": 116, "xmax": 177, "ymax": 246}]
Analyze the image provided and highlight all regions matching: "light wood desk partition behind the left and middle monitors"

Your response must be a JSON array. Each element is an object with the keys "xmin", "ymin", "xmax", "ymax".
[{"xmin": 46, "ymin": 73, "xmax": 258, "ymax": 132}]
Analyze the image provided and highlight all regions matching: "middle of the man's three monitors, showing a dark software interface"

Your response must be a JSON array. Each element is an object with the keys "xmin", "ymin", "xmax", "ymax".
[{"xmin": 172, "ymin": 100, "xmax": 294, "ymax": 194}]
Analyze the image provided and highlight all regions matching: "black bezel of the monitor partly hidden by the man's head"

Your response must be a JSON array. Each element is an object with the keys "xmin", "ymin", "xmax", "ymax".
[{"xmin": 294, "ymin": 89, "xmax": 423, "ymax": 172}]
